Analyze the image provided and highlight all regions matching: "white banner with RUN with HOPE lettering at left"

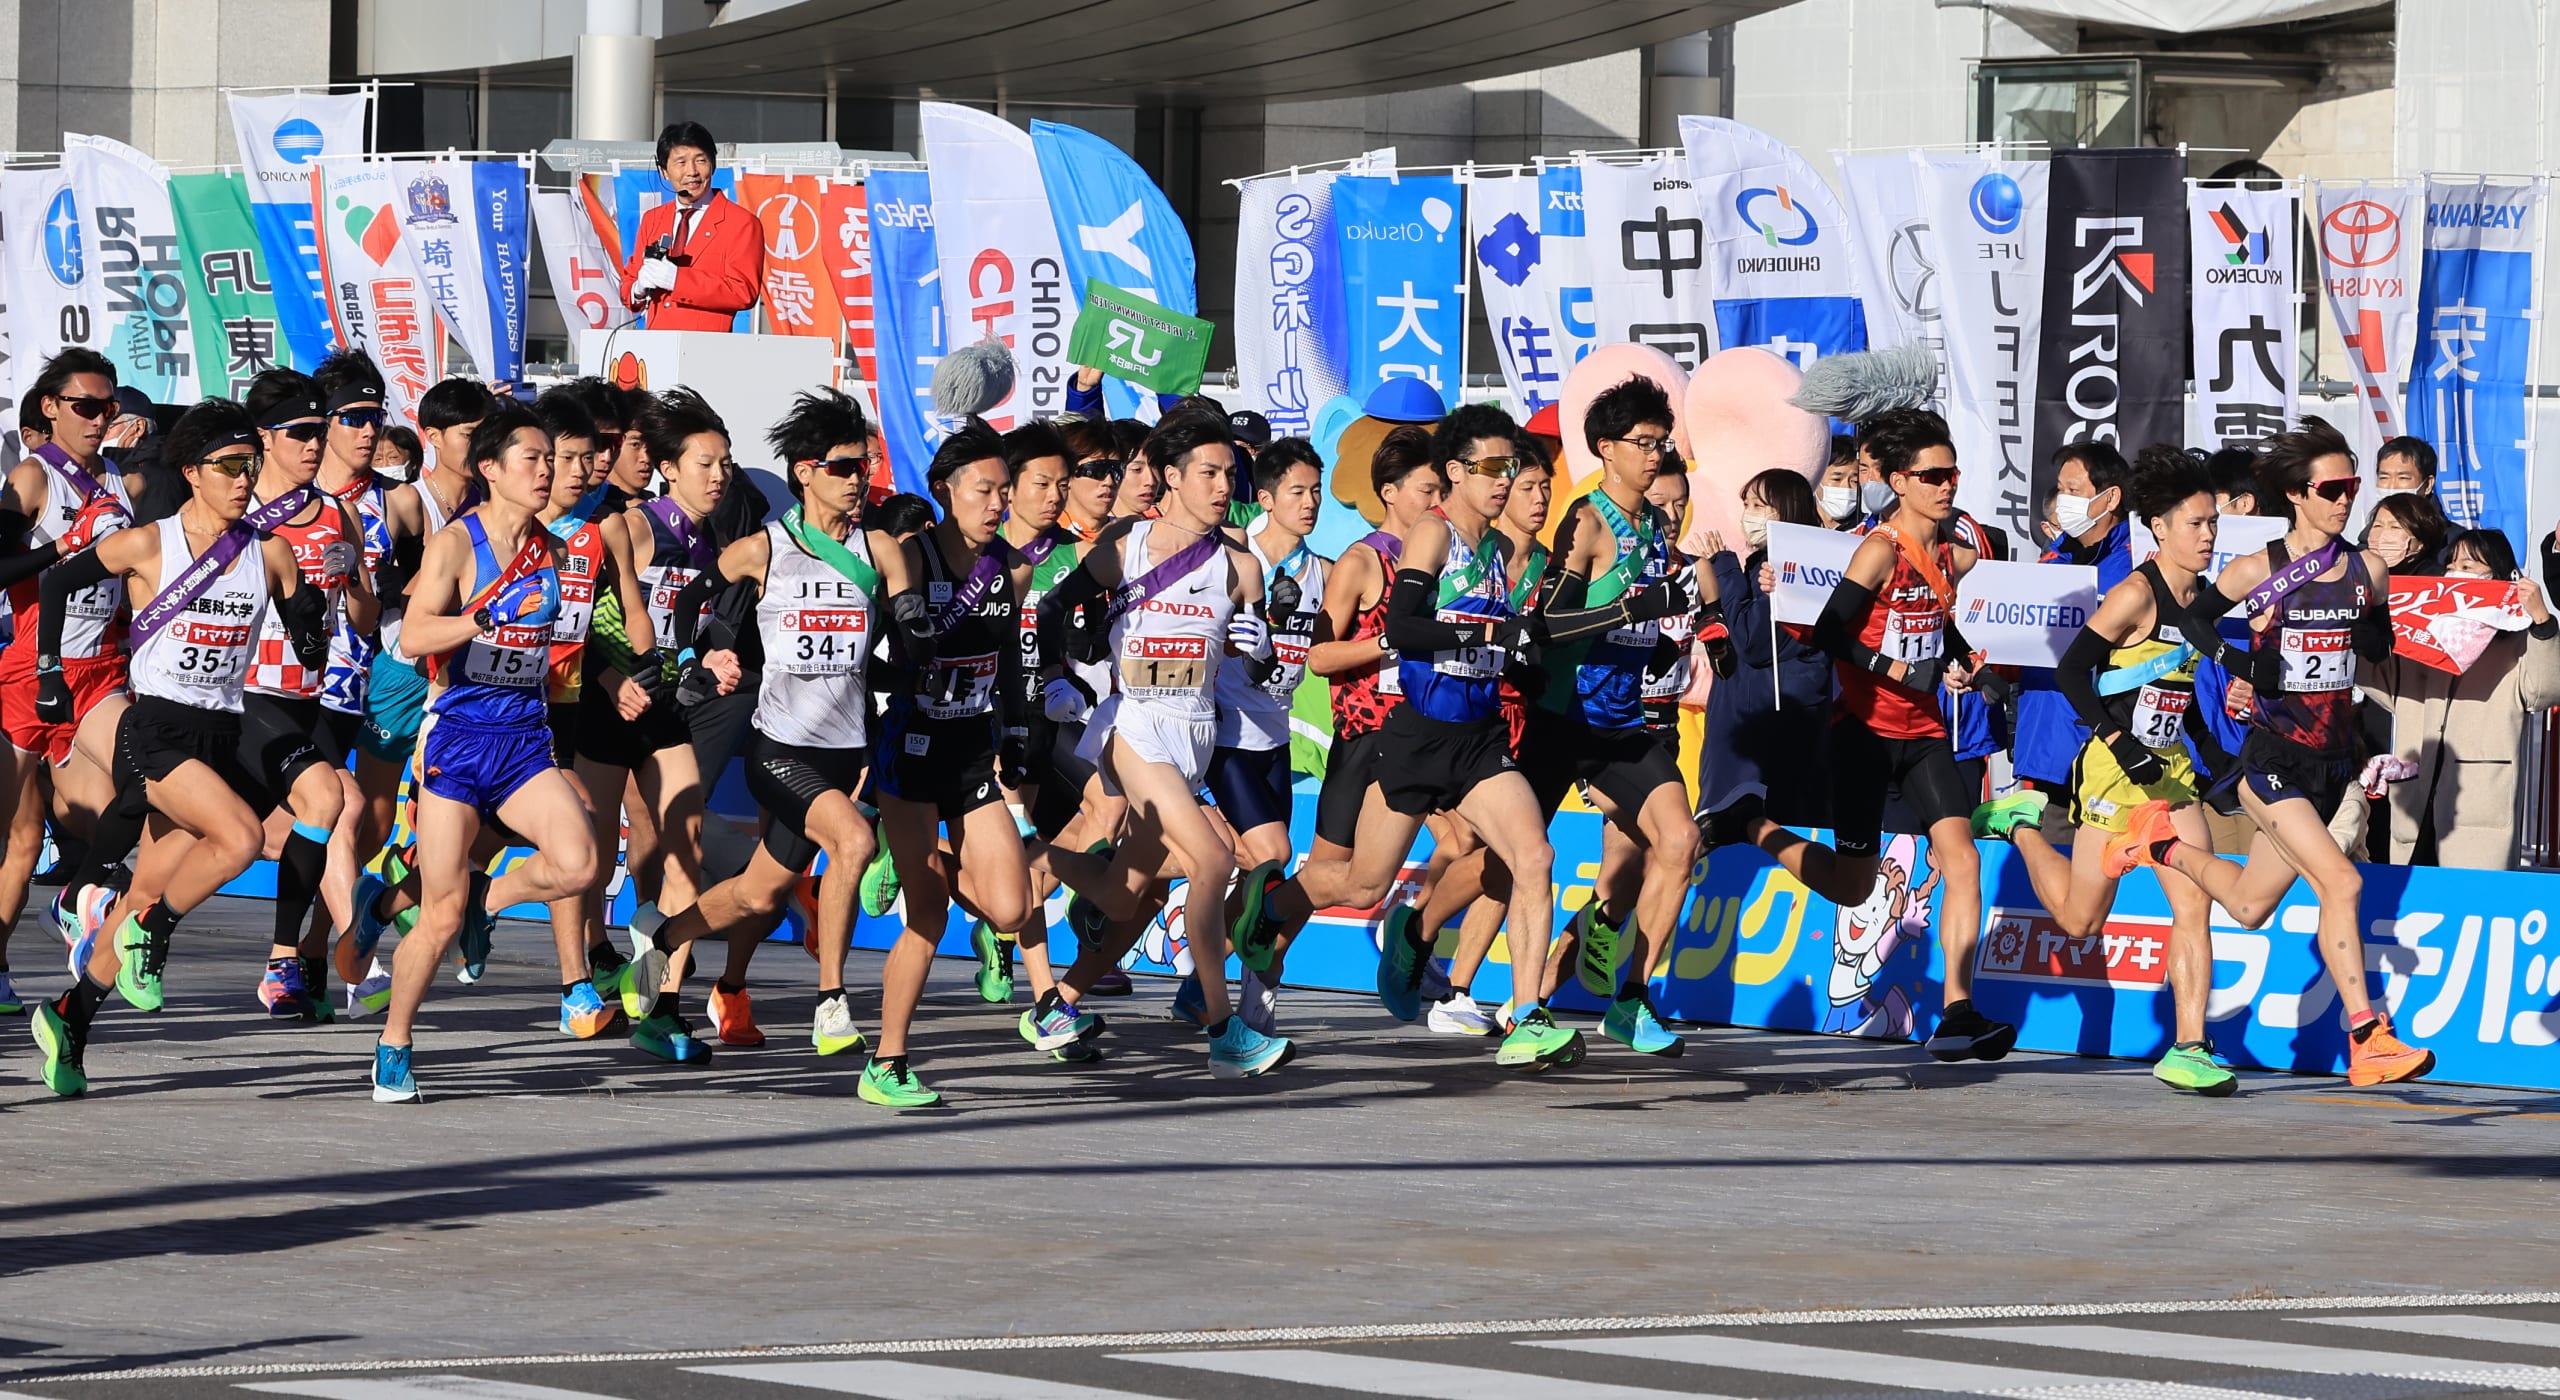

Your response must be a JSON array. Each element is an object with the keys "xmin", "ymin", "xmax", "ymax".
[{"xmin": 61, "ymin": 133, "xmax": 200, "ymax": 404}]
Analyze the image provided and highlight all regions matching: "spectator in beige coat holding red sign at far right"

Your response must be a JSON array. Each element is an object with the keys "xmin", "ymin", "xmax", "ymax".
[{"xmin": 2360, "ymin": 530, "xmax": 2560, "ymax": 870}]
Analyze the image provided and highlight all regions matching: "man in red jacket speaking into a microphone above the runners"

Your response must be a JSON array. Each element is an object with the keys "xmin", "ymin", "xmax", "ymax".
[{"xmin": 622, "ymin": 120, "xmax": 765, "ymax": 330}]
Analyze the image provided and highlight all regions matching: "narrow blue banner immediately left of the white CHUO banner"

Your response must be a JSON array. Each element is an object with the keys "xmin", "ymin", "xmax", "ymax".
[{"xmin": 868, "ymin": 169, "xmax": 942, "ymax": 499}]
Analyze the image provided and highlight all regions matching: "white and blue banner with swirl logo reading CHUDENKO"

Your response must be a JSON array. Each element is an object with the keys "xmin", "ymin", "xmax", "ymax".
[{"xmin": 1679, "ymin": 118, "xmax": 1866, "ymax": 369}]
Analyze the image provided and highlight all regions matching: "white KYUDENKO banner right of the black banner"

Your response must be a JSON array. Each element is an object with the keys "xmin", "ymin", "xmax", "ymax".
[{"xmin": 2186, "ymin": 179, "xmax": 2301, "ymax": 448}]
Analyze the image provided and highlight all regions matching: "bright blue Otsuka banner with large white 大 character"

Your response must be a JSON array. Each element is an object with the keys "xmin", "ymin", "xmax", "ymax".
[{"xmin": 1334, "ymin": 174, "xmax": 1467, "ymax": 402}]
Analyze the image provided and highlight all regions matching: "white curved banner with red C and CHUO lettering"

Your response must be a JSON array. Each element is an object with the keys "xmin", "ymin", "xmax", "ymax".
[{"xmin": 919, "ymin": 102, "xmax": 1075, "ymax": 430}]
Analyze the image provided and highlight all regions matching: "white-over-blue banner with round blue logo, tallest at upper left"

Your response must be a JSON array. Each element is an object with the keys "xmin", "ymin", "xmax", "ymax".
[{"xmin": 230, "ymin": 92, "xmax": 374, "ymax": 371}]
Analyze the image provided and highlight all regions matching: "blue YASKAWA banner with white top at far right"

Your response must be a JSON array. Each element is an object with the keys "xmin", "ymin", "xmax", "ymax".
[{"xmin": 2406, "ymin": 177, "xmax": 2542, "ymax": 555}]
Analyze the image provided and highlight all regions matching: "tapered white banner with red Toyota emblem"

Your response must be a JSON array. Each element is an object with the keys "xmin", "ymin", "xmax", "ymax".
[{"xmin": 2312, "ymin": 179, "xmax": 2419, "ymax": 438}]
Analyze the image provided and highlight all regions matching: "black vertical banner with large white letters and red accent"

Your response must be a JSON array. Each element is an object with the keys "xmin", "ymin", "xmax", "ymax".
[{"xmin": 2033, "ymin": 146, "xmax": 2186, "ymax": 532}]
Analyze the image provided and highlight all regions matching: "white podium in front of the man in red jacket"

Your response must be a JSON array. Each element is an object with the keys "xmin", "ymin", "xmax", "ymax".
[{"xmin": 579, "ymin": 328, "xmax": 835, "ymax": 476}]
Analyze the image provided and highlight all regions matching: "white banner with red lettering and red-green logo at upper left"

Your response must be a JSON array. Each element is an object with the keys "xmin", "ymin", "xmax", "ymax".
[{"xmin": 312, "ymin": 161, "xmax": 445, "ymax": 427}]
